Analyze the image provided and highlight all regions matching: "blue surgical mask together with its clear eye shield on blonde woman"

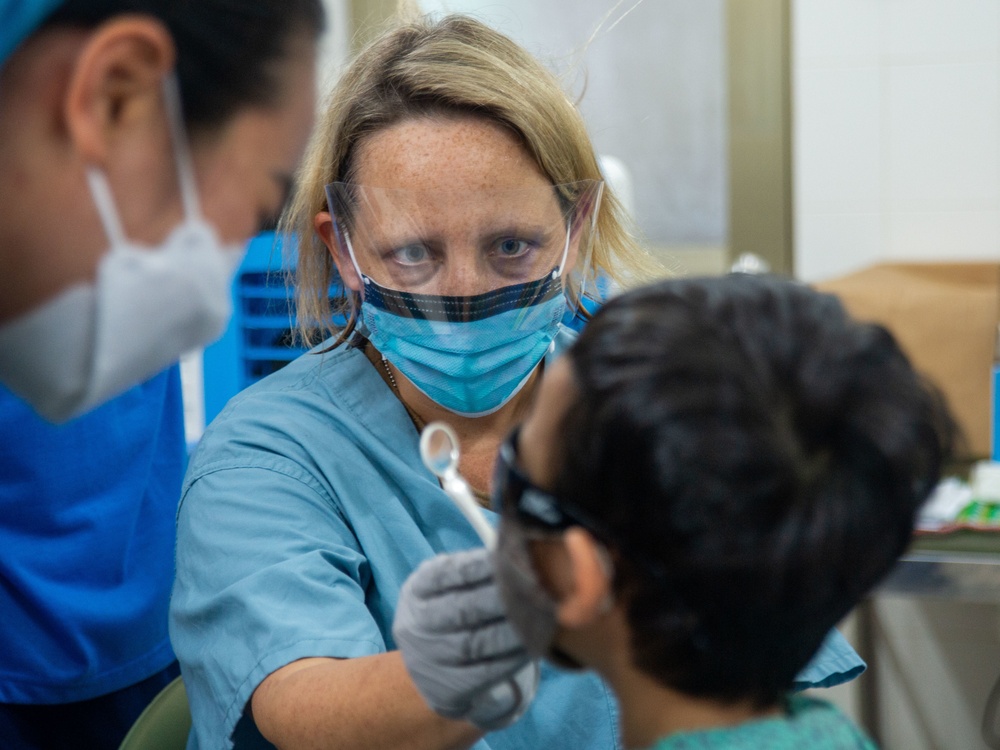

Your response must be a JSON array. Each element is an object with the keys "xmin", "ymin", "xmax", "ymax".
[{"xmin": 326, "ymin": 180, "xmax": 602, "ymax": 417}]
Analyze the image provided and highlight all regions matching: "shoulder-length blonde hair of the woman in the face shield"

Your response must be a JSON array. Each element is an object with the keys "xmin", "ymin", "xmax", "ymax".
[{"xmin": 280, "ymin": 13, "xmax": 663, "ymax": 344}]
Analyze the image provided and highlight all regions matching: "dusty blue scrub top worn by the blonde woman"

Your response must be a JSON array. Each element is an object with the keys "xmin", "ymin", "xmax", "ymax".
[{"xmin": 170, "ymin": 330, "xmax": 860, "ymax": 750}]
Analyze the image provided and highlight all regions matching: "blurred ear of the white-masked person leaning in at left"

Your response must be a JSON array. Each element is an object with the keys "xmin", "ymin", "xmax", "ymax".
[{"xmin": 64, "ymin": 16, "xmax": 175, "ymax": 165}]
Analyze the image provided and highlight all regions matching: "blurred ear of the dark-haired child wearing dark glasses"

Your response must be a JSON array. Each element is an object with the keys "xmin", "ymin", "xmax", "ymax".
[{"xmin": 556, "ymin": 526, "xmax": 613, "ymax": 628}]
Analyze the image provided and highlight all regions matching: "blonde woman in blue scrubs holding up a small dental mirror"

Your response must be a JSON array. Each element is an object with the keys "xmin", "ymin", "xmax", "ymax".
[{"xmin": 171, "ymin": 16, "xmax": 858, "ymax": 750}]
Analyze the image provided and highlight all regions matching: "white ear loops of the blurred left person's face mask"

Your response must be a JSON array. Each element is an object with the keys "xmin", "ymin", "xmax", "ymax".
[{"xmin": 87, "ymin": 75, "xmax": 201, "ymax": 242}]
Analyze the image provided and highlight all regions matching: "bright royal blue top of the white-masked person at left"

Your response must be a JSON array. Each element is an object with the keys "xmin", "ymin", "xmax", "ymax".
[{"xmin": 0, "ymin": 365, "xmax": 186, "ymax": 704}]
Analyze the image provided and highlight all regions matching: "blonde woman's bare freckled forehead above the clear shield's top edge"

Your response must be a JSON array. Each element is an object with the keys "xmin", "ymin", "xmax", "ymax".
[{"xmin": 351, "ymin": 116, "xmax": 551, "ymax": 190}]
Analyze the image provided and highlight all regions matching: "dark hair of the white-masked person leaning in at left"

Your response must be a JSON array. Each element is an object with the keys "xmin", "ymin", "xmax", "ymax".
[{"xmin": 45, "ymin": 0, "xmax": 325, "ymax": 130}]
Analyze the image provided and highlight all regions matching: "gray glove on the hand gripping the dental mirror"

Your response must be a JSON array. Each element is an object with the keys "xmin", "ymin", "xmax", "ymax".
[{"xmin": 392, "ymin": 549, "xmax": 539, "ymax": 730}]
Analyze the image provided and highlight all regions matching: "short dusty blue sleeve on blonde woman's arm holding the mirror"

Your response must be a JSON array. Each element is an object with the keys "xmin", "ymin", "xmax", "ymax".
[{"xmin": 170, "ymin": 456, "xmax": 386, "ymax": 748}]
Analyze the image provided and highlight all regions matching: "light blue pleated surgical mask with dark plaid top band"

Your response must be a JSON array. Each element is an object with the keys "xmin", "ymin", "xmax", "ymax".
[{"xmin": 361, "ymin": 269, "xmax": 567, "ymax": 417}]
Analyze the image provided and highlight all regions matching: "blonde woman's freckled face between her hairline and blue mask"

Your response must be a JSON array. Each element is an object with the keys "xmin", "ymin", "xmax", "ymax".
[{"xmin": 335, "ymin": 117, "xmax": 575, "ymax": 296}]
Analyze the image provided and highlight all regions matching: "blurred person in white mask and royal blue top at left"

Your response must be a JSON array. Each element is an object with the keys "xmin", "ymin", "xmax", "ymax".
[{"xmin": 0, "ymin": 0, "xmax": 323, "ymax": 750}]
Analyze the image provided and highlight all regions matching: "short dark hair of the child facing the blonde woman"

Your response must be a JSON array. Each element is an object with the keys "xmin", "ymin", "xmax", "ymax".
[{"xmin": 553, "ymin": 274, "xmax": 955, "ymax": 706}]
